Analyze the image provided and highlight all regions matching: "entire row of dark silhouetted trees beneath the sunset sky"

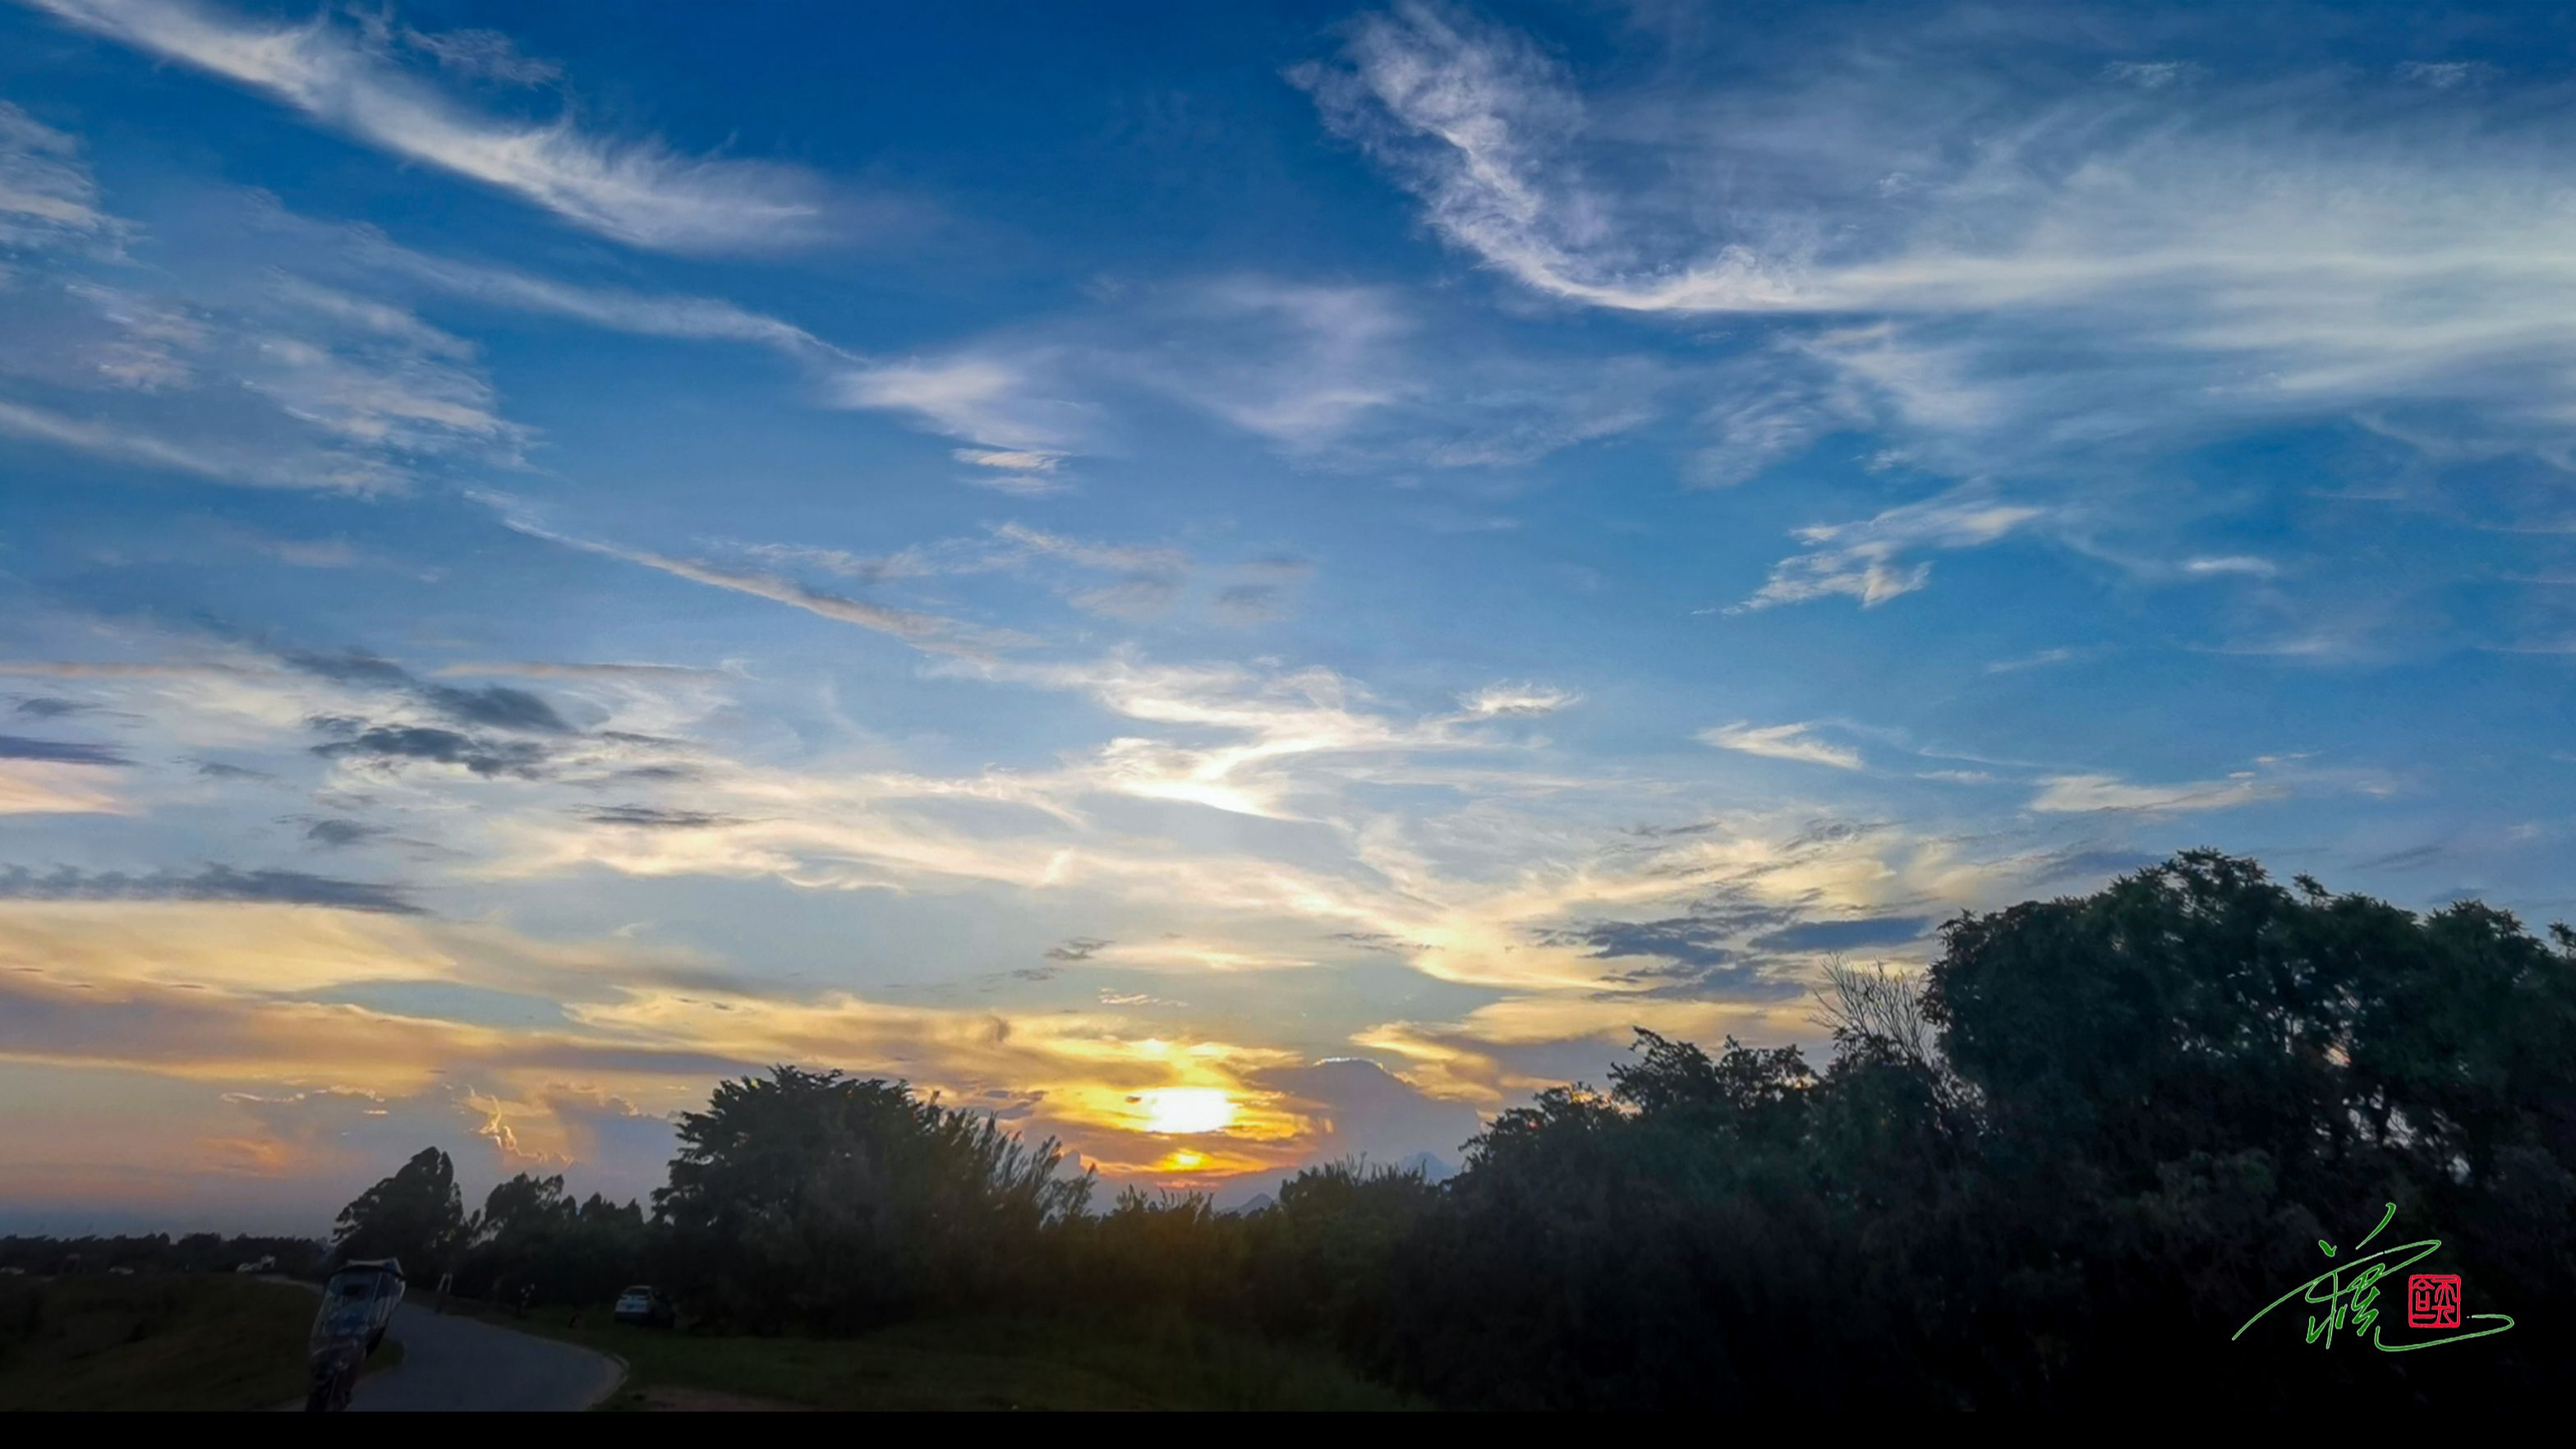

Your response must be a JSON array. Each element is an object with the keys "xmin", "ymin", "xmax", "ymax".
[{"xmin": 311, "ymin": 851, "xmax": 2576, "ymax": 1410}]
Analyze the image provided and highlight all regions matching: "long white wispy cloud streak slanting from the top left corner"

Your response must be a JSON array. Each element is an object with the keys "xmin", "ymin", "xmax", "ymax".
[{"xmin": 34, "ymin": 0, "xmax": 830, "ymax": 253}]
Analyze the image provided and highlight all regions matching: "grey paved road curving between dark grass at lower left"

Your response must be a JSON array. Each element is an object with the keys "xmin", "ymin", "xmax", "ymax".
[{"xmin": 347, "ymin": 1302, "xmax": 626, "ymax": 1413}]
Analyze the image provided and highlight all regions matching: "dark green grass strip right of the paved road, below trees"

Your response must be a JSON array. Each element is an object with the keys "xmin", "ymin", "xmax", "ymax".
[{"xmin": 474, "ymin": 1310, "xmax": 1419, "ymax": 1410}]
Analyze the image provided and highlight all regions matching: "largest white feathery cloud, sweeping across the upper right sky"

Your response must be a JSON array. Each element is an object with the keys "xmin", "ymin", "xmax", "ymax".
[{"xmin": 1288, "ymin": 2, "xmax": 2576, "ymax": 499}]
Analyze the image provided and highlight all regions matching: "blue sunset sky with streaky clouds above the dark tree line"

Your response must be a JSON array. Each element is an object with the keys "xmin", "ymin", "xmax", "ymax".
[{"xmin": 0, "ymin": 0, "xmax": 2576, "ymax": 1232}]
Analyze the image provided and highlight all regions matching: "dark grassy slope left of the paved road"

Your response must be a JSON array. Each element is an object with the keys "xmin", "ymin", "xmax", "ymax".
[{"xmin": 0, "ymin": 1274, "xmax": 322, "ymax": 1410}]
